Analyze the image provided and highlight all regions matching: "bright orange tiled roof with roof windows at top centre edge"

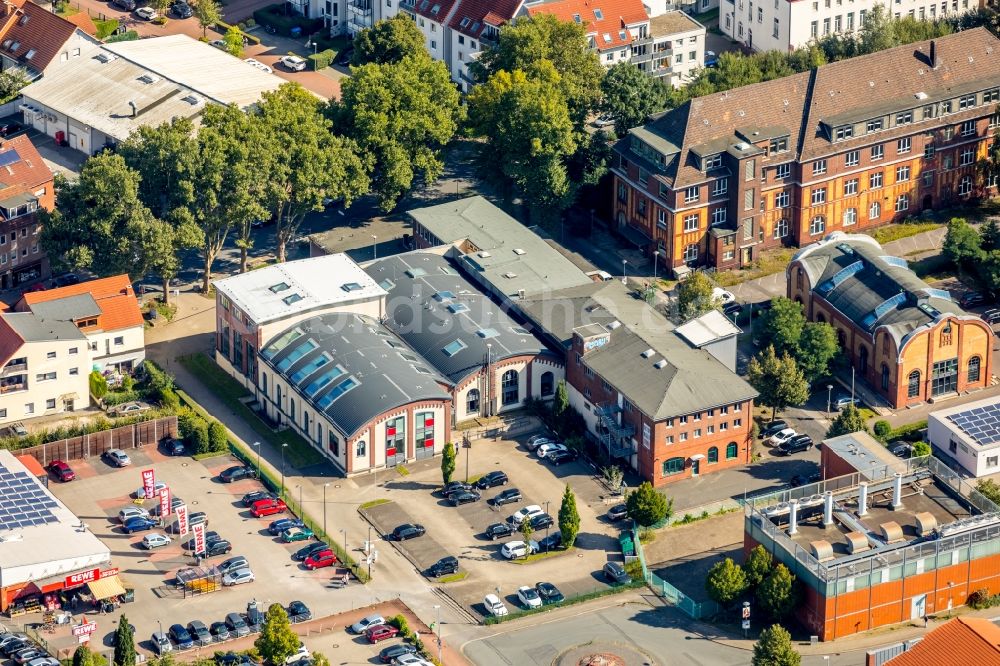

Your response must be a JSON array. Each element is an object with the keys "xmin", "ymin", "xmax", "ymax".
[{"xmin": 527, "ymin": 0, "xmax": 649, "ymax": 51}]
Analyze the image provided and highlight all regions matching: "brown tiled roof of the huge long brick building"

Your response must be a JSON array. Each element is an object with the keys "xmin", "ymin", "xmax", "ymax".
[{"xmin": 632, "ymin": 28, "xmax": 1000, "ymax": 188}]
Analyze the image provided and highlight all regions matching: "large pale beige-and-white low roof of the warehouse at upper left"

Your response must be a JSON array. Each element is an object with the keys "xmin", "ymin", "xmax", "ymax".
[{"xmin": 21, "ymin": 35, "xmax": 285, "ymax": 141}]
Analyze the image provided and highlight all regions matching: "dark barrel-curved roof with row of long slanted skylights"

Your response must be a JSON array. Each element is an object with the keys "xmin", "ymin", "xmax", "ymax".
[{"xmin": 261, "ymin": 313, "xmax": 451, "ymax": 437}]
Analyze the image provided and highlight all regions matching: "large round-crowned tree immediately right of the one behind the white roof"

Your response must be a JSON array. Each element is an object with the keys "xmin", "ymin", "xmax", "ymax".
[{"xmin": 331, "ymin": 53, "xmax": 463, "ymax": 212}]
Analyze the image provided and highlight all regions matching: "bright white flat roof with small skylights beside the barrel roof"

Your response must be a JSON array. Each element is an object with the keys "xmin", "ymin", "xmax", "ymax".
[{"xmin": 213, "ymin": 254, "xmax": 386, "ymax": 326}]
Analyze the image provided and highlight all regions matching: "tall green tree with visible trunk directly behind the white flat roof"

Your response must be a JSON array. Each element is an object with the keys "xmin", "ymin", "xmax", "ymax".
[{"xmin": 253, "ymin": 83, "xmax": 369, "ymax": 262}]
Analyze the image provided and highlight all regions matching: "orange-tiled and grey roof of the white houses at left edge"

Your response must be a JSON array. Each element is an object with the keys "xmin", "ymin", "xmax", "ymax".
[{"xmin": 16, "ymin": 275, "xmax": 143, "ymax": 331}]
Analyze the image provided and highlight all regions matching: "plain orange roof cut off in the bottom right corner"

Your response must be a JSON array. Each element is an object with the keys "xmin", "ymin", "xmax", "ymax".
[{"xmin": 886, "ymin": 617, "xmax": 1000, "ymax": 666}]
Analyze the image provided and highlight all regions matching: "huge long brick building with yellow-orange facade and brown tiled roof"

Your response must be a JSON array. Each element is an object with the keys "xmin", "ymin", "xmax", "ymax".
[{"xmin": 612, "ymin": 28, "xmax": 1000, "ymax": 275}]
